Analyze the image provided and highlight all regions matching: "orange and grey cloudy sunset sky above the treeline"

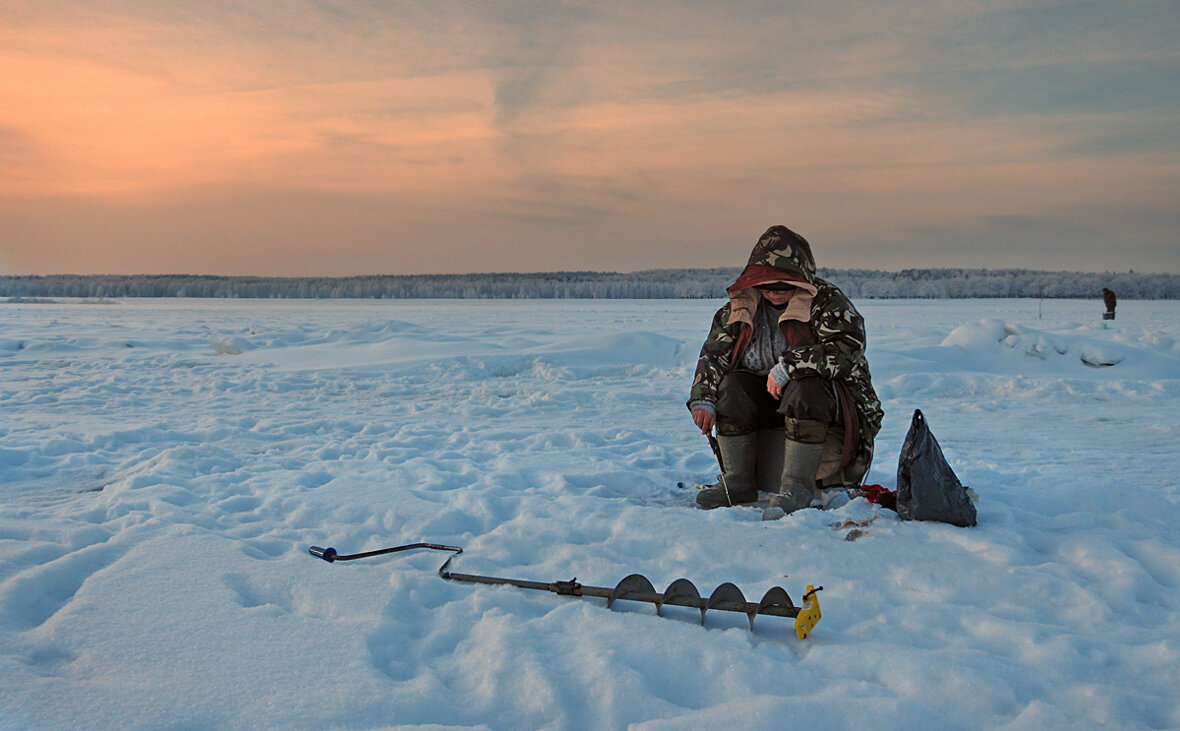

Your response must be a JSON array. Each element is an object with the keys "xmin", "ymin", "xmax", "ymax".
[{"xmin": 0, "ymin": 0, "xmax": 1180, "ymax": 275}]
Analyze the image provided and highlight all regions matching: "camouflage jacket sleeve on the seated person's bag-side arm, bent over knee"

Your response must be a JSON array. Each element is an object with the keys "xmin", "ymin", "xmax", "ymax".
[{"xmin": 780, "ymin": 291, "xmax": 865, "ymax": 380}]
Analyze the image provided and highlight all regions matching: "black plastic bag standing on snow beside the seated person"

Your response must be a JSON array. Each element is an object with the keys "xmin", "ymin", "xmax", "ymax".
[{"xmin": 897, "ymin": 410, "xmax": 975, "ymax": 528}]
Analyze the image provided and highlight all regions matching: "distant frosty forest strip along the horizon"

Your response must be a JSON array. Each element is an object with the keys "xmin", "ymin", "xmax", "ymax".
[{"xmin": 0, "ymin": 268, "xmax": 1180, "ymax": 301}]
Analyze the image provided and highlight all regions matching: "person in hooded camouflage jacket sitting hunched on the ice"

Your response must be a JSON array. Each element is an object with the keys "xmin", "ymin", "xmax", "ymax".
[{"xmin": 688, "ymin": 226, "xmax": 884, "ymax": 517}]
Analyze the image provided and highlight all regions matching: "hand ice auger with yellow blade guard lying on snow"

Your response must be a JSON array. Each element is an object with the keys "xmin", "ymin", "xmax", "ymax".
[{"xmin": 308, "ymin": 543, "xmax": 824, "ymax": 639}]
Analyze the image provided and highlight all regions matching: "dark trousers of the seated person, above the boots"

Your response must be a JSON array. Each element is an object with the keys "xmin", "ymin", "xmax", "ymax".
[{"xmin": 717, "ymin": 371, "xmax": 839, "ymax": 437}]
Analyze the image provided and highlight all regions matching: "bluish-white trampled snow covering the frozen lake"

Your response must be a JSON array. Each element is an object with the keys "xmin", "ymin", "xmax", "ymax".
[{"xmin": 0, "ymin": 300, "xmax": 1180, "ymax": 729}]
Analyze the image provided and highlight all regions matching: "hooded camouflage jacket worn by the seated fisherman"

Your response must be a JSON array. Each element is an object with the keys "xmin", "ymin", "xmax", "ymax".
[{"xmin": 688, "ymin": 226, "xmax": 884, "ymax": 463}]
